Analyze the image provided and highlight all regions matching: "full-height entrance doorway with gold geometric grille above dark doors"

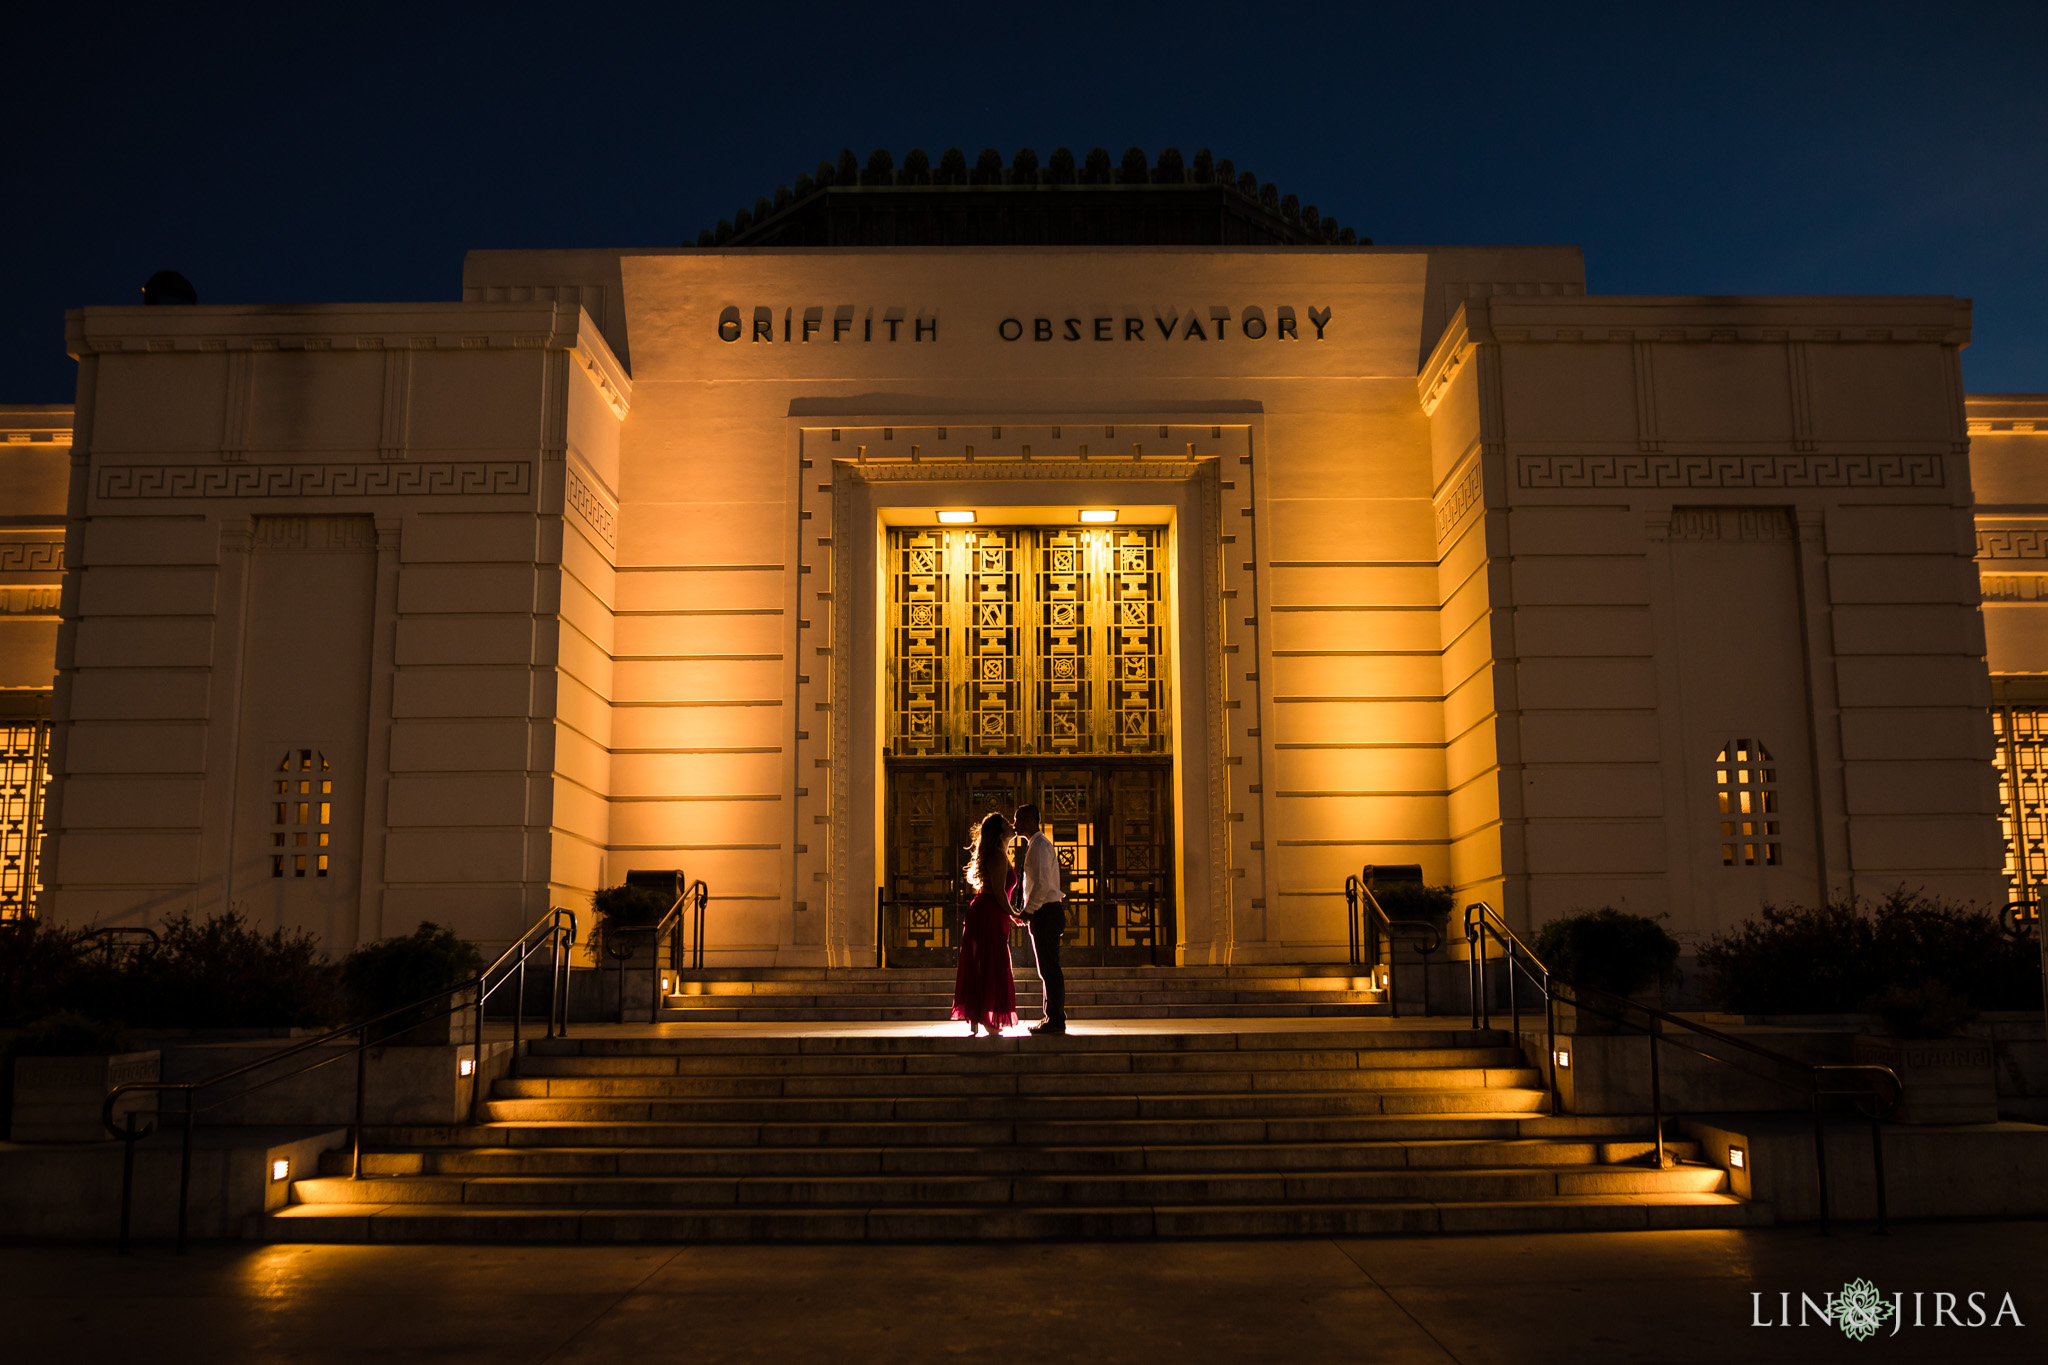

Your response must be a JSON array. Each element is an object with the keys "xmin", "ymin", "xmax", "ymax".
[{"xmin": 881, "ymin": 517, "xmax": 1176, "ymax": 966}]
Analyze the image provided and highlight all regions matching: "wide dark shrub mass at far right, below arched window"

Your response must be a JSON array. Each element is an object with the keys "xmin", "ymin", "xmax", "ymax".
[{"xmin": 1700, "ymin": 886, "xmax": 2042, "ymax": 1015}]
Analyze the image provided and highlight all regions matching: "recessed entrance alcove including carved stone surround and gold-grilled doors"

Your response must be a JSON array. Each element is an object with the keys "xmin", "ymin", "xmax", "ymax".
[{"xmin": 797, "ymin": 415, "xmax": 1257, "ymax": 966}]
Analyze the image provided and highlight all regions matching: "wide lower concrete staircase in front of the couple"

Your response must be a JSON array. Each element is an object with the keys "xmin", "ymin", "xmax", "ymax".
[{"xmin": 252, "ymin": 1021, "xmax": 1769, "ymax": 1242}]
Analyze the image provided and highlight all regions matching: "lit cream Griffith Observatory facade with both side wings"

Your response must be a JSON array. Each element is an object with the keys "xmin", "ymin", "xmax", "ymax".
[{"xmin": 0, "ymin": 187, "xmax": 2048, "ymax": 964}]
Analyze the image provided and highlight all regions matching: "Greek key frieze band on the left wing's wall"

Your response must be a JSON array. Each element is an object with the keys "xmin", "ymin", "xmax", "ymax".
[{"xmin": 94, "ymin": 460, "xmax": 532, "ymax": 501}]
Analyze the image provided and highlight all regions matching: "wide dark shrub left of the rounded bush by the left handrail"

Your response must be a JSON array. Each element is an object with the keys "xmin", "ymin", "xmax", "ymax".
[{"xmin": 109, "ymin": 911, "xmax": 342, "ymax": 1029}]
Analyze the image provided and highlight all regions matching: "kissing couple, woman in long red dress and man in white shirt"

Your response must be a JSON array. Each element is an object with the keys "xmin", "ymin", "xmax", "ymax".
[{"xmin": 952, "ymin": 804, "xmax": 1067, "ymax": 1038}]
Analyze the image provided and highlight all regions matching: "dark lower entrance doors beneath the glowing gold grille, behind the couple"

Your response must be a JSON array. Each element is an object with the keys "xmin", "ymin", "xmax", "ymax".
[{"xmin": 881, "ymin": 759, "xmax": 1176, "ymax": 966}]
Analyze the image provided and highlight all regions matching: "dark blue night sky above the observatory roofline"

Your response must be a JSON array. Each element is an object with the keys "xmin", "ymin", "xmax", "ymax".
[{"xmin": 0, "ymin": 0, "xmax": 2048, "ymax": 403}]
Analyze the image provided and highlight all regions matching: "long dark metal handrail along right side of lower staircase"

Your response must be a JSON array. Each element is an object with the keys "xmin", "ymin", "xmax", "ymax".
[{"xmin": 1464, "ymin": 900, "xmax": 1905, "ymax": 1232}]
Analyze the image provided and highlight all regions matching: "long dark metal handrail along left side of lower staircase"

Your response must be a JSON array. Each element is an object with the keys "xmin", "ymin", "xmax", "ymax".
[{"xmin": 100, "ymin": 909, "xmax": 575, "ymax": 1254}]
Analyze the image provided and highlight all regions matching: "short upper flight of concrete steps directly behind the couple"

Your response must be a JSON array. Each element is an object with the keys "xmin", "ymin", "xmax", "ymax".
[{"xmin": 641, "ymin": 964, "xmax": 1389, "ymax": 1023}]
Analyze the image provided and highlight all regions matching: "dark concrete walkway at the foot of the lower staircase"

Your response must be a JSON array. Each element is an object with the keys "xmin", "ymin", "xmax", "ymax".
[{"xmin": 0, "ymin": 1222, "xmax": 2048, "ymax": 1365}]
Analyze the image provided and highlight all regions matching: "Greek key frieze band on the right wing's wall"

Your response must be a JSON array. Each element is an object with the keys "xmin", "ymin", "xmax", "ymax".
[{"xmin": 1516, "ymin": 454, "xmax": 1946, "ymax": 489}]
